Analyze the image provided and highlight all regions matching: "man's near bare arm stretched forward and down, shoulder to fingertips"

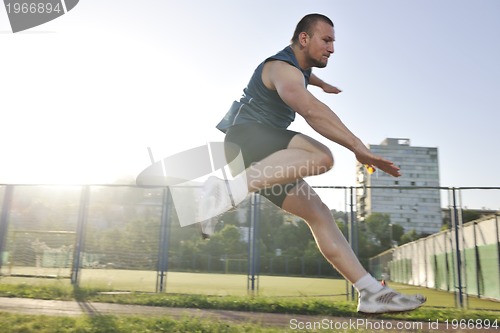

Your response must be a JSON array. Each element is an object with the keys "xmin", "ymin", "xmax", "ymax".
[{"xmin": 263, "ymin": 61, "xmax": 400, "ymax": 177}]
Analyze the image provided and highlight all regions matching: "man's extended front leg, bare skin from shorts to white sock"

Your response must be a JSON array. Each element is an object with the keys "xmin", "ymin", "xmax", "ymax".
[{"xmin": 282, "ymin": 181, "xmax": 367, "ymax": 283}]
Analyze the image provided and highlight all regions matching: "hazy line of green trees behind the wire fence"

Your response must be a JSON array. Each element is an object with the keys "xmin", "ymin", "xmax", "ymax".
[{"xmin": 4, "ymin": 187, "xmax": 430, "ymax": 276}]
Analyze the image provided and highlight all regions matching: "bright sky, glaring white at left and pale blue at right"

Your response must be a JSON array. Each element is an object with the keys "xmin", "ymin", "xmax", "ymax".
[{"xmin": 0, "ymin": 0, "xmax": 500, "ymax": 209}]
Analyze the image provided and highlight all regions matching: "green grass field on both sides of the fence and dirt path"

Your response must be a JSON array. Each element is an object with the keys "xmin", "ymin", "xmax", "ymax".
[{"xmin": 0, "ymin": 270, "xmax": 500, "ymax": 333}]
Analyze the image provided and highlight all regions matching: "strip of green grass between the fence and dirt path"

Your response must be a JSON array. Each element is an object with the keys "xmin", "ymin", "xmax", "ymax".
[{"xmin": 0, "ymin": 278, "xmax": 500, "ymax": 321}]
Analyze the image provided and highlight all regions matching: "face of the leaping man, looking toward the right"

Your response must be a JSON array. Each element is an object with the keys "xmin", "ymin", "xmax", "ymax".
[{"xmin": 307, "ymin": 21, "xmax": 335, "ymax": 68}]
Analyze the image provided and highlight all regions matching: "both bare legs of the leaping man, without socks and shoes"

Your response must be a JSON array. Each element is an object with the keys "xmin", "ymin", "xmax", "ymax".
[{"xmin": 242, "ymin": 134, "xmax": 367, "ymax": 283}]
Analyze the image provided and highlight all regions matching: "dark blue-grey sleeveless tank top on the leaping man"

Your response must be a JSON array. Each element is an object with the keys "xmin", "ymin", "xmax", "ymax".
[{"xmin": 216, "ymin": 46, "xmax": 311, "ymax": 133}]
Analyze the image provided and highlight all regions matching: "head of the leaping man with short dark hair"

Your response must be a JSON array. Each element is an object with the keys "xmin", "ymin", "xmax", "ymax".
[{"xmin": 292, "ymin": 14, "xmax": 335, "ymax": 68}]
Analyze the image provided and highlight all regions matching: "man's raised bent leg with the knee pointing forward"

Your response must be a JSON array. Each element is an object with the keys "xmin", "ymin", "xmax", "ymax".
[{"xmin": 246, "ymin": 134, "xmax": 333, "ymax": 192}]
